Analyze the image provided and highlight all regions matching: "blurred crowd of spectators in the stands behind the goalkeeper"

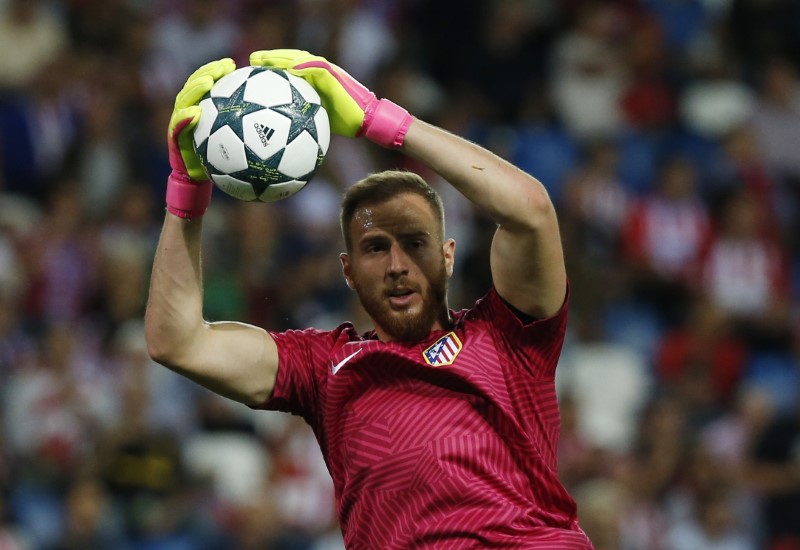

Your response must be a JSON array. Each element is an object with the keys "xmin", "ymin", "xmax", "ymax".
[{"xmin": 0, "ymin": 0, "xmax": 800, "ymax": 550}]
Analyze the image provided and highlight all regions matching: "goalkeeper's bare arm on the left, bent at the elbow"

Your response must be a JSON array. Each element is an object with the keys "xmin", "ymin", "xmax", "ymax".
[{"xmin": 145, "ymin": 214, "xmax": 278, "ymax": 405}]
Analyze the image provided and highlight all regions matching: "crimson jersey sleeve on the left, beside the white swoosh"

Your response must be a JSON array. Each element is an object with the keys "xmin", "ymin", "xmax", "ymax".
[{"xmin": 257, "ymin": 329, "xmax": 336, "ymax": 425}]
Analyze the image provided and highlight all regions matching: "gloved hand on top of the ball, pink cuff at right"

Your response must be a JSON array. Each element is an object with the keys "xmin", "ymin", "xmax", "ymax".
[{"xmin": 250, "ymin": 50, "xmax": 414, "ymax": 148}]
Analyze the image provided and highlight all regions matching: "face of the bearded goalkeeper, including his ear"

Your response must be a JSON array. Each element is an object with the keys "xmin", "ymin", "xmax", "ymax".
[{"xmin": 341, "ymin": 193, "xmax": 455, "ymax": 342}]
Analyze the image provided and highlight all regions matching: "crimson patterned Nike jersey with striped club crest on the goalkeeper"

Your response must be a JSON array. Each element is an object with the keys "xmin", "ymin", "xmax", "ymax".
[{"xmin": 263, "ymin": 290, "xmax": 592, "ymax": 550}]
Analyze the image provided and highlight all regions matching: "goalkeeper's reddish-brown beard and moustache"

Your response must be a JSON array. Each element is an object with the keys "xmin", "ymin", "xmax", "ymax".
[{"xmin": 354, "ymin": 260, "xmax": 447, "ymax": 343}]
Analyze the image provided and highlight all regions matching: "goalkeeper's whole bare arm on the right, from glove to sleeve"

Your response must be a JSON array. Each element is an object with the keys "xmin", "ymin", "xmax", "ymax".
[{"xmin": 402, "ymin": 120, "xmax": 567, "ymax": 318}]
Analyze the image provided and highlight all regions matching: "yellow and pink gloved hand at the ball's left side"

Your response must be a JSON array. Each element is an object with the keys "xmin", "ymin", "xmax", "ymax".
[{"xmin": 167, "ymin": 59, "xmax": 236, "ymax": 218}]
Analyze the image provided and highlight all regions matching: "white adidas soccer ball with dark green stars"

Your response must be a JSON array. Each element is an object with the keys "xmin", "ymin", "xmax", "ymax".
[{"xmin": 194, "ymin": 67, "xmax": 330, "ymax": 202}]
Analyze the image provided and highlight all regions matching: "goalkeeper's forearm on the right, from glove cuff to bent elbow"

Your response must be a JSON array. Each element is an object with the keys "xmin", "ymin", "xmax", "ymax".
[{"xmin": 402, "ymin": 119, "xmax": 552, "ymax": 230}]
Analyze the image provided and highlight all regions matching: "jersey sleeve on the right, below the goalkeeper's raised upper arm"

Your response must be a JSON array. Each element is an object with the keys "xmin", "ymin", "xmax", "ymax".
[{"xmin": 477, "ymin": 288, "xmax": 569, "ymax": 379}]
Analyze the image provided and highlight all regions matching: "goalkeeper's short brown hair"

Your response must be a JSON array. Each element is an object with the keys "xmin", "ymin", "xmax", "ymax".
[{"xmin": 339, "ymin": 170, "xmax": 444, "ymax": 252}]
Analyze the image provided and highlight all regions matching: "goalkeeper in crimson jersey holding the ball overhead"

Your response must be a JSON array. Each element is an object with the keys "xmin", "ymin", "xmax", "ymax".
[{"xmin": 146, "ymin": 50, "xmax": 592, "ymax": 550}]
